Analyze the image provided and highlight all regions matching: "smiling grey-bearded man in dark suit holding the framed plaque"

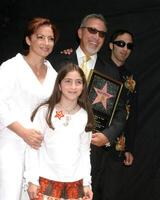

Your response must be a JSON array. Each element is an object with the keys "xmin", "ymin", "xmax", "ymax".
[{"xmin": 53, "ymin": 14, "xmax": 126, "ymax": 198}]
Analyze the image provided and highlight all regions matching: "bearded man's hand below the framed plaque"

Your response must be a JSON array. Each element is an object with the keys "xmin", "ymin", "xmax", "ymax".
[{"xmin": 91, "ymin": 132, "xmax": 109, "ymax": 147}]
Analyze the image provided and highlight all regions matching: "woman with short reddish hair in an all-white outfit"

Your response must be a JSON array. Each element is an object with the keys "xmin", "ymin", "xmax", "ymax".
[{"xmin": 0, "ymin": 18, "xmax": 58, "ymax": 200}]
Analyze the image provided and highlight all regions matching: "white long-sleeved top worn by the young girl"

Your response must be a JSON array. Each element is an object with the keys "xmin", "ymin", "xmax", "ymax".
[{"xmin": 25, "ymin": 106, "xmax": 91, "ymax": 185}]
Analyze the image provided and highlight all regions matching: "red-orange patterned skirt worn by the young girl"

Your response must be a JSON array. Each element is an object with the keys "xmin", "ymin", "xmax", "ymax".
[{"xmin": 36, "ymin": 177, "xmax": 84, "ymax": 200}]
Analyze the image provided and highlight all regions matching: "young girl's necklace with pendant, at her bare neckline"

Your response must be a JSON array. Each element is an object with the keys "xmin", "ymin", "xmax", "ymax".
[{"xmin": 57, "ymin": 103, "xmax": 78, "ymax": 126}]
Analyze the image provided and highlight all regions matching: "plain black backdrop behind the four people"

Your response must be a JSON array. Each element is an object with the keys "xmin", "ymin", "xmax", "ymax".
[{"xmin": 0, "ymin": 0, "xmax": 160, "ymax": 200}]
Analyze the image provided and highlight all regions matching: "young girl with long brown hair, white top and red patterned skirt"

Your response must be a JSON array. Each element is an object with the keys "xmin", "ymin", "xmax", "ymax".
[{"xmin": 25, "ymin": 63, "xmax": 94, "ymax": 200}]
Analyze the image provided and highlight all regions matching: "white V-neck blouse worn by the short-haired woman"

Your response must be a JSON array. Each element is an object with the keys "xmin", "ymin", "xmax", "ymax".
[{"xmin": 0, "ymin": 53, "xmax": 57, "ymax": 139}]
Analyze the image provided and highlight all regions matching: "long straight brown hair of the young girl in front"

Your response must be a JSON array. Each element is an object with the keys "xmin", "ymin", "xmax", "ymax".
[{"xmin": 31, "ymin": 62, "xmax": 94, "ymax": 131}]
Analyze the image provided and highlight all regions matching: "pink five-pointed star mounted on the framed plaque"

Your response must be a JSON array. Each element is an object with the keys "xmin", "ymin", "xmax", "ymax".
[{"xmin": 92, "ymin": 83, "xmax": 113, "ymax": 109}]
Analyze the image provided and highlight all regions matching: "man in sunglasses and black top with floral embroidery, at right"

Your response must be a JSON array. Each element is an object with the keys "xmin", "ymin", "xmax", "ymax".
[{"xmin": 95, "ymin": 30, "xmax": 137, "ymax": 200}]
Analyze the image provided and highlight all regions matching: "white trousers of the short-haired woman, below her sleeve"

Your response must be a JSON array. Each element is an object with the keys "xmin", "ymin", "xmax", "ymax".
[{"xmin": 0, "ymin": 133, "xmax": 26, "ymax": 200}]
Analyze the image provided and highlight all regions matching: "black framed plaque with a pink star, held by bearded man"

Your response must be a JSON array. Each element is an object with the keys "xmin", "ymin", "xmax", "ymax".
[{"xmin": 88, "ymin": 70, "xmax": 123, "ymax": 131}]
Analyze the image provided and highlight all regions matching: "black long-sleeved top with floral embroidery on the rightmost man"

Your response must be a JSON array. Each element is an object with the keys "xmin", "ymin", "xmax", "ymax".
[{"xmin": 109, "ymin": 60, "xmax": 138, "ymax": 153}]
